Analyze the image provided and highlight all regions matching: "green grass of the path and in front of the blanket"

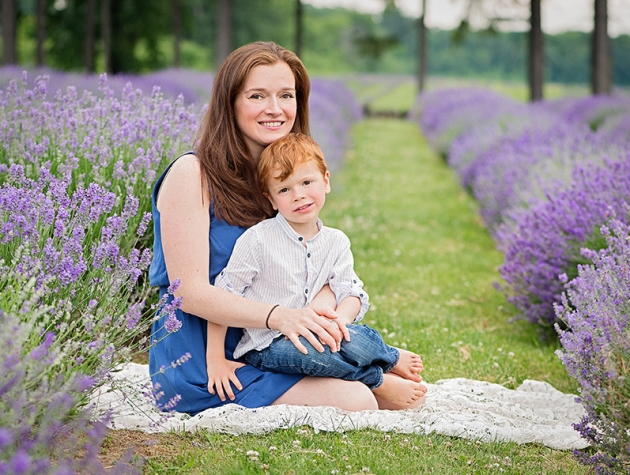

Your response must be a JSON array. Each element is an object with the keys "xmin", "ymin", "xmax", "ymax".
[{"xmin": 103, "ymin": 119, "xmax": 588, "ymax": 475}]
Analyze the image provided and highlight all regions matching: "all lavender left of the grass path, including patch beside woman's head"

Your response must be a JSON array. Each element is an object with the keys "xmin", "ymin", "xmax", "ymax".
[{"xmin": 0, "ymin": 68, "xmax": 361, "ymax": 473}]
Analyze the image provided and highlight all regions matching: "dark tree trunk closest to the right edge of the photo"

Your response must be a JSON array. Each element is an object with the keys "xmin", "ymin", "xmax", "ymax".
[{"xmin": 591, "ymin": 0, "xmax": 612, "ymax": 94}]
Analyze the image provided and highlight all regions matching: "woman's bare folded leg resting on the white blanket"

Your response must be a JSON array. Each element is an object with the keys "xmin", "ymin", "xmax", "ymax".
[{"xmin": 273, "ymin": 376, "xmax": 379, "ymax": 411}]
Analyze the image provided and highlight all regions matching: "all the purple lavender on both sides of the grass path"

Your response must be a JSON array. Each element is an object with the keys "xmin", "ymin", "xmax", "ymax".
[{"xmin": 0, "ymin": 62, "xmax": 630, "ymax": 474}]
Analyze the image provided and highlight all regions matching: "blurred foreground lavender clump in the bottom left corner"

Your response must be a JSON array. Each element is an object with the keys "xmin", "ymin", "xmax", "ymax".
[{"xmin": 0, "ymin": 311, "xmax": 139, "ymax": 475}]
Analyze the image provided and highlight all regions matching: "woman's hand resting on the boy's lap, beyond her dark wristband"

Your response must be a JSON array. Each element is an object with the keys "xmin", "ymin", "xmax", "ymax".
[{"xmin": 268, "ymin": 307, "xmax": 343, "ymax": 354}]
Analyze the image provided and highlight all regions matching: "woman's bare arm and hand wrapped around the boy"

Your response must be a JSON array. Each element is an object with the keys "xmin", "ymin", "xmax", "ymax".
[{"xmin": 157, "ymin": 155, "xmax": 341, "ymax": 351}]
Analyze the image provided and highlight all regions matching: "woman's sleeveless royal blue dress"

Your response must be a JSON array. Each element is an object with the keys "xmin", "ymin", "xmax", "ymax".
[{"xmin": 149, "ymin": 157, "xmax": 303, "ymax": 415}]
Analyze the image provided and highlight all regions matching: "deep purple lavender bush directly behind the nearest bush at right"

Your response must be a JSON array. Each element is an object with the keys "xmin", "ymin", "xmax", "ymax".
[{"xmin": 497, "ymin": 157, "xmax": 630, "ymax": 326}]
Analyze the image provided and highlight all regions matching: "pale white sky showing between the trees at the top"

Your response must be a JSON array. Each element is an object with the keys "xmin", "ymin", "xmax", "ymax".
[{"xmin": 302, "ymin": 0, "xmax": 630, "ymax": 36}]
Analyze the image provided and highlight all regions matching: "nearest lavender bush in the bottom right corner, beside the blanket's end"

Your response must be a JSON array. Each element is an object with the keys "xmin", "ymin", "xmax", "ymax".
[{"xmin": 555, "ymin": 214, "xmax": 630, "ymax": 473}]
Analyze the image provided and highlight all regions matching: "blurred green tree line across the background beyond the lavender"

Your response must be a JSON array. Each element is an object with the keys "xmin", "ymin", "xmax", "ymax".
[{"xmin": 0, "ymin": 0, "xmax": 630, "ymax": 99}]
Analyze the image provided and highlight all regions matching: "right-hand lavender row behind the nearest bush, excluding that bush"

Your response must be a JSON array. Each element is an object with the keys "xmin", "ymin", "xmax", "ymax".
[{"xmin": 413, "ymin": 89, "xmax": 630, "ymax": 327}]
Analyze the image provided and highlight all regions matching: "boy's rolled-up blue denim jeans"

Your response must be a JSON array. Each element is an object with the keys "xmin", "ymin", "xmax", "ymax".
[{"xmin": 243, "ymin": 324, "xmax": 400, "ymax": 389}]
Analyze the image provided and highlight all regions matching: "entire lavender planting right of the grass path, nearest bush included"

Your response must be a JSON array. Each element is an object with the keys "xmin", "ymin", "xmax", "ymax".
[{"xmin": 412, "ymin": 88, "xmax": 630, "ymax": 473}]
